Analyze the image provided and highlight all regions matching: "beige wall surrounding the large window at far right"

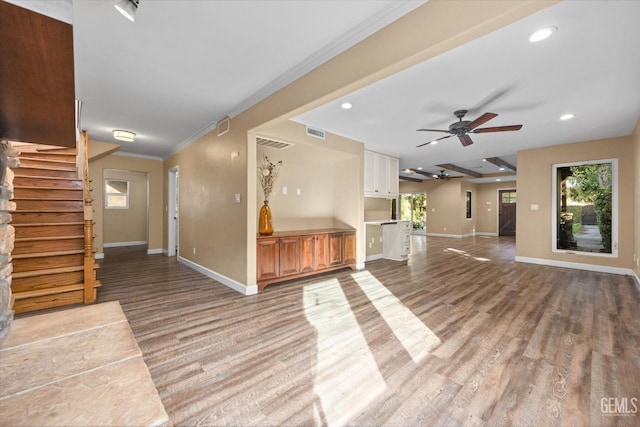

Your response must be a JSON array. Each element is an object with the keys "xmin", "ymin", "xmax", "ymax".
[{"xmin": 516, "ymin": 136, "xmax": 634, "ymax": 268}]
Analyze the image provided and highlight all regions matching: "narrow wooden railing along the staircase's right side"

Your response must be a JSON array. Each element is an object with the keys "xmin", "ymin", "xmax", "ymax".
[{"xmin": 77, "ymin": 131, "xmax": 96, "ymax": 304}]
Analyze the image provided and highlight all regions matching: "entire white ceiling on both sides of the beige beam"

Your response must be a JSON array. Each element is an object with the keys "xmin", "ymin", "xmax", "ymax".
[{"xmin": 10, "ymin": 0, "xmax": 640, "ymax": 179}]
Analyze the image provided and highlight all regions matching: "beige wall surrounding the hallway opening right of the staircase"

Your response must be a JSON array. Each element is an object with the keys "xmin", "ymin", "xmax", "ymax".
[{"xmin": 89, "ymin": 148, "xmax": 166, "ymax": 253}]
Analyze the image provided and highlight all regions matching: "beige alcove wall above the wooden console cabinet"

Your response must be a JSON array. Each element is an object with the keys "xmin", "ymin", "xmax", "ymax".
[{"xmin": 252, "ymin": 122, "xmax": 364, "ymax": 231}]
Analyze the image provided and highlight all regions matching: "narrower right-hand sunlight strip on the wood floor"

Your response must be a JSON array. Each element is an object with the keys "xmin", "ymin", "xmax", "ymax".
[{"xmin": 351, "ymin": 271, "xmax": 440, "ymax": 363}]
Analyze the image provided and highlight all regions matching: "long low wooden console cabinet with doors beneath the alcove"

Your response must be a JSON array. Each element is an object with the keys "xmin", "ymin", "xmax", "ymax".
[{"xmin": 257, "ymin": 229, "xmax": 356, "ymax": 290}]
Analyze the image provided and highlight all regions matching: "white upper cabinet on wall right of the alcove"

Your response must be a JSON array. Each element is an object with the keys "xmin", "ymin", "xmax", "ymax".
[{"xmin": 364, "ymin": 150, "xmax": 399, "ymax": 198}]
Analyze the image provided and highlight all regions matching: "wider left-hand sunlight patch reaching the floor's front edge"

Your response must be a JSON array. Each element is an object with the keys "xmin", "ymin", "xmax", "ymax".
[{"xmin": 303, "ymin": 279, "xmax": 387, "ymax": 425}]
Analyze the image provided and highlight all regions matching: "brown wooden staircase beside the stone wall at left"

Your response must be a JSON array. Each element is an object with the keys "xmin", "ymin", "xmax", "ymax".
[{"xmin": 11, "ymin": 140, "xmax": 100, "ymax": 313}]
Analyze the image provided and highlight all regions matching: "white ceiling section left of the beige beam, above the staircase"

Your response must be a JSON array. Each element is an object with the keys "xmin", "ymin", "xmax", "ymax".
[{"xmin": 73, "ymin": 0, "xmax": 422, "ymax": 157}]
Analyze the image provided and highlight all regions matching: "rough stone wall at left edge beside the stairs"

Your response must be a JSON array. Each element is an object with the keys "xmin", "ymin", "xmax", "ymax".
[{"xmin": 0, "ymin": 140, "xmax": 19, "ymax": 346}]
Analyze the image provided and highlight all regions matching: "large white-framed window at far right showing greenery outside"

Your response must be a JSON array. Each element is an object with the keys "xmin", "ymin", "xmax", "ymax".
[{"xmin": 552, "ymin": 160, "xmax": 618, "ymax": 256}]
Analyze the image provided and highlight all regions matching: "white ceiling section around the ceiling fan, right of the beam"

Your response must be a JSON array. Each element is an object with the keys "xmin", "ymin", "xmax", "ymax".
[{"xmin": 294, "ymin": 1, "xmax": 640, "ymax": 182}]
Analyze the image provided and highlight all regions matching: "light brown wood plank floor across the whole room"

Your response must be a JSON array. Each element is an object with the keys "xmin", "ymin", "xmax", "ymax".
[{"xmin": 98, "ymin": 236, "xmax": 640, "ymax": 426}]
